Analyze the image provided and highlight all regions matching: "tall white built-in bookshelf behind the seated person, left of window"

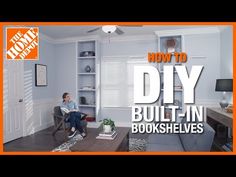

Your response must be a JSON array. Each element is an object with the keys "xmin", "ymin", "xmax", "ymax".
[{"xmin": 76, "ymin": 40, "xmax": 100, "ymax": 122}]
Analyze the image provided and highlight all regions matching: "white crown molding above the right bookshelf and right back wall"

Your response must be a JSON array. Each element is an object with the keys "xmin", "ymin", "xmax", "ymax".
[{"xmin": 155, "ymin": 27, "xmax": 220, "ymax": 37}]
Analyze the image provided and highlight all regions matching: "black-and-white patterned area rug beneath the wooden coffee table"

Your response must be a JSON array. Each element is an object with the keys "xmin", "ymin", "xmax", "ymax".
[{"xmin": 52, "ymin": 134, "xmax": 147, "ymax": 152}]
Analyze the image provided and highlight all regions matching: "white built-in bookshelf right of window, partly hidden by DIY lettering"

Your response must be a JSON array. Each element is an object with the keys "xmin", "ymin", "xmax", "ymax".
[{"xmin": 157, "ymin": 34, "xmax": 185, "ymax": 122}]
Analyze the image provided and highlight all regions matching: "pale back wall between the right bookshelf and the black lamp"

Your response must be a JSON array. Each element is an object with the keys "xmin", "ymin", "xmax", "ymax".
[{"xmin": 185, "ymin": 33, "xmax": 220, "ymax": 102}]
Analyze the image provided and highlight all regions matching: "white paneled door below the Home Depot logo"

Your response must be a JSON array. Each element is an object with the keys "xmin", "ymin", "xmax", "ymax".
[{"xmin": 3, "ymin": 60, "xmax": 24, "ymax": 143}]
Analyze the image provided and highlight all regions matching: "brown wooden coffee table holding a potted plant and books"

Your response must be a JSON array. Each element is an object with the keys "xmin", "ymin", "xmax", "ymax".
[{"xmin": 70, "ymin": 127, "xmax": 130, "ymax": 152}]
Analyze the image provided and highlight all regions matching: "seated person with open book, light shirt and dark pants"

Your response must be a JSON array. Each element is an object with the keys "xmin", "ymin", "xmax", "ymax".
[{"xmin": 61, "ymin": 92, "xmax": 86, "ymax": 138}]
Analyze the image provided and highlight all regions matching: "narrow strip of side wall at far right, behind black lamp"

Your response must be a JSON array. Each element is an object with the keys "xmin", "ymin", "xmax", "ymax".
[{"xmin": 220, "ymin": 27, "xmax": 233, "ymax": 103}]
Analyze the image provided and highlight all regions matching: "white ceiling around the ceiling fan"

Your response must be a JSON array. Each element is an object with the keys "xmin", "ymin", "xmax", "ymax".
[{"xmin": 40, "ymin": 25, "xmax": 230, "ymax": 39}]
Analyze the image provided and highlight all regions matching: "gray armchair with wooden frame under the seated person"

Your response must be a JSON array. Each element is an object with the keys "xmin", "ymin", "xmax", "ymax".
[{"xmin": 52, "ymin": 106, "xmax": 87, "ymax": 136}]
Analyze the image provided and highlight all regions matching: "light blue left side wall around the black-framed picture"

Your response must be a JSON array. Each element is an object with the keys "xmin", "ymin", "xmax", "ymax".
[{"xmin": 24, "ymin": 38, "xmax": 56, "ymax": 100}]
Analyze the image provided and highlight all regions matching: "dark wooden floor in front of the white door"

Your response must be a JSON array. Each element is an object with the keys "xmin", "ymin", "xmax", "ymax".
[{"xmin": 3, "ymin": 127, "xmax": 148, "ymax": 152}]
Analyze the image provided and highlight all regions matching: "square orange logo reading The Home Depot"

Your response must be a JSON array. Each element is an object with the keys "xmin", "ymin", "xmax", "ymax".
[{"xmin": 6, "ymin": 27, "xmax": 39, "ymax": 60}]
